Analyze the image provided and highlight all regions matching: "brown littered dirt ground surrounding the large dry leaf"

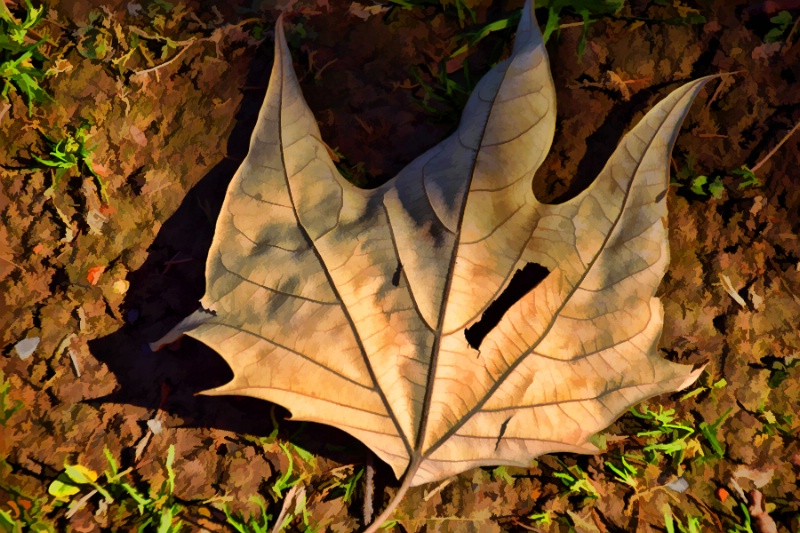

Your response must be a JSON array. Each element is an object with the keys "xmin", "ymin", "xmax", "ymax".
[{"xmin": 0, "ymin": 0, "xmax": 800, "ymax": 533}]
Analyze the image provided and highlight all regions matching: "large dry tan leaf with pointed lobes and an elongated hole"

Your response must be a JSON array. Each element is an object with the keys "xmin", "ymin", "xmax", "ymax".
[{"xmin": 155, "ymin": 2, "xmax": 705, "ymax": 524}]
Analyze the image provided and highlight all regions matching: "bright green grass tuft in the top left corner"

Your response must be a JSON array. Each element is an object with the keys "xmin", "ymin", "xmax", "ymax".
[{"xmin": 0, "ymin": 0, "xmax": 51, "ymax": 117}]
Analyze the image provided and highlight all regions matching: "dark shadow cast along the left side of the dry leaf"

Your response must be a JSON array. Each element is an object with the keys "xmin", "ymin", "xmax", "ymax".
[{"xmin": 86, "ymin": 37, "xmax": 384, "ymax": 479}]
